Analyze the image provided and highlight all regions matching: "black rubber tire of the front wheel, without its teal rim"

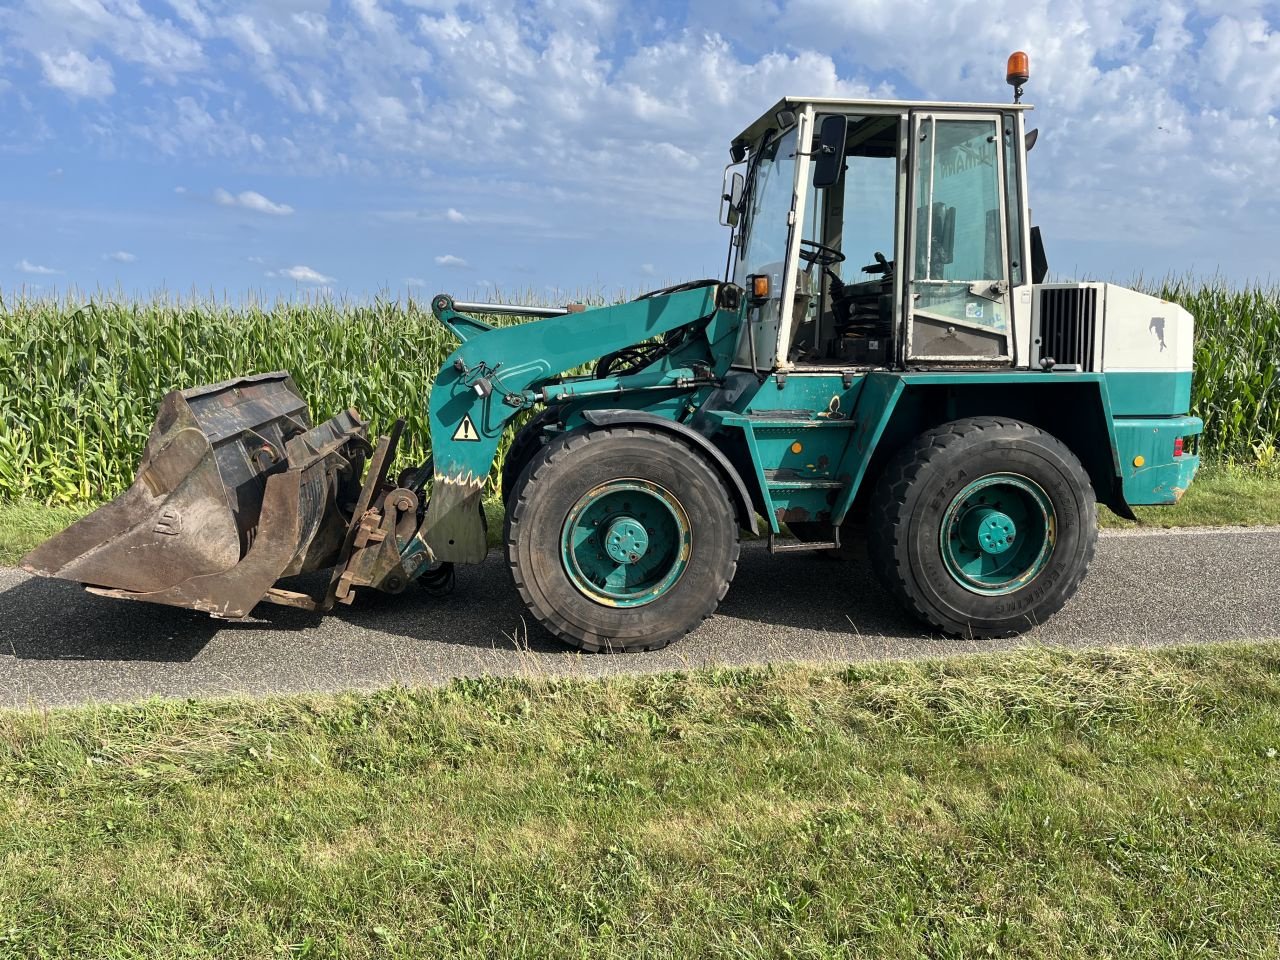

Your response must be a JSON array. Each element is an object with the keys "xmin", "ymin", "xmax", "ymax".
[{"xmin": 506, "ymin": 426, "xmax": 739, "ymax": 653}]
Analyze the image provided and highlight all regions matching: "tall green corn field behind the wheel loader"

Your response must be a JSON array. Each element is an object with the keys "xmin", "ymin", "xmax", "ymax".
[{"xmin": 0, "ymin": 279, "xmax": 1280, "ymax": 503}]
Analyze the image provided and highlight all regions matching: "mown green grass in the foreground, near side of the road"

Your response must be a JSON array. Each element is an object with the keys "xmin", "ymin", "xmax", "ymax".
[{"xmin": 0, "ymin": 643, "xmax": 1280, "ymax": 960}]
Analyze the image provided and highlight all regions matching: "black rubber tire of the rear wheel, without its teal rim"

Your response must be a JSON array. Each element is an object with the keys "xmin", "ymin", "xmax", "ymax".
[{"xmin": 868, "ymin": 417, "xmax": 1098, "ymax": 637}]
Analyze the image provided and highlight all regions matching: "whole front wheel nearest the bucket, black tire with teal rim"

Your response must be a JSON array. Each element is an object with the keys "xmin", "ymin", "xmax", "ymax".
[{"xmin": 506, "ymin": 426, "xmax": 739, "ymax": 652}]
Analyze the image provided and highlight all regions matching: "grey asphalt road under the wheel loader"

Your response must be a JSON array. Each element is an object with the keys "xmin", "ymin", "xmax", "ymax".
[{"xmin": 0, "ymin": 527, "xmax": 1280, "ymax": 707}]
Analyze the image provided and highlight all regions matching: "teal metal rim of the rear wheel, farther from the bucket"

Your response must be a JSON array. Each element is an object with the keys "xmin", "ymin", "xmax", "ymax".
[{"xmin": 941, "ymin": 474, "xmax": 1057, "ymax": 596}]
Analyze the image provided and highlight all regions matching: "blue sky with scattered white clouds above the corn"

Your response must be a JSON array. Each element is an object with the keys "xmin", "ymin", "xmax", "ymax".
[{"xmin": 0, "ymin": 0, "xmax": 1280, "ymax": 298}]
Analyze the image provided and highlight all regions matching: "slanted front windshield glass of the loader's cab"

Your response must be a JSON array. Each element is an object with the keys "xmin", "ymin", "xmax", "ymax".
[{"xmin": 733, "ymin": 127, "xmax": 796, "ymax": 289}]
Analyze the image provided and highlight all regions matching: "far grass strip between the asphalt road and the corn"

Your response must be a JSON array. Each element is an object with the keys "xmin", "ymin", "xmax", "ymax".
[{"xmin": 0, "ymin": 466, "xmax": 1280, "ymax": 566}]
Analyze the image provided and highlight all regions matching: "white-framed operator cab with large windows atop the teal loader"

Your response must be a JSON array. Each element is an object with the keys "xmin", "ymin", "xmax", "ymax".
[{"xmin": 723, "ymin": 99, "xmax": 1030, "ymax": 372}]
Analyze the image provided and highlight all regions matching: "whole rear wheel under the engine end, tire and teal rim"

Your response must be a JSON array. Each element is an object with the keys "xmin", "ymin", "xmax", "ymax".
[{"xmin": 868, "ymin": 417, "xmax": 1098, "ymax": 637}]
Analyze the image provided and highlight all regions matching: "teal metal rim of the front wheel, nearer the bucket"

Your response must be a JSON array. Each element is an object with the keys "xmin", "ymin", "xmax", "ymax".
[{"xmin": 561, "ymin": 480, "xmax": 692, "ymax": 607}]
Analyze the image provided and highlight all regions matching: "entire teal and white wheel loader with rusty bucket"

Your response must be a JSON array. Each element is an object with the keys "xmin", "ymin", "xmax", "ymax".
[{"xmin": 24, "ymin": 54, "xmax": 1202, "ymax": 650}]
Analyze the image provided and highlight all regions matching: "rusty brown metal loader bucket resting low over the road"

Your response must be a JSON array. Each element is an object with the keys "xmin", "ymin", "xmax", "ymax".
[{"xmin": 23, "ymin": 372, "xmax": 369, "ymax": 617}]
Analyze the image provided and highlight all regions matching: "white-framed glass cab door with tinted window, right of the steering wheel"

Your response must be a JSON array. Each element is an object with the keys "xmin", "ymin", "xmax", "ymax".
[{"xmin": 905, "ymin": 111, "xmax": 1012, "ymax": 365}]
